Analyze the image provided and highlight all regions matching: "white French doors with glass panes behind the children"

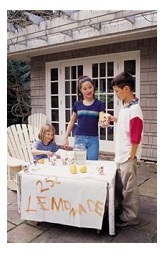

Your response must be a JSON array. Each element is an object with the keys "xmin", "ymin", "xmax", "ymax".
[{"xmin": 46, "ymin": 51, "xmax": 140, "ymax": 152}]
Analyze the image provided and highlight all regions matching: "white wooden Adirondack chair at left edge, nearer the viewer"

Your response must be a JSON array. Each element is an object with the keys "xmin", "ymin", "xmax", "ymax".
[{"xmin": 7, "ymin": 124, "xmax": 38, "ymax": 190}]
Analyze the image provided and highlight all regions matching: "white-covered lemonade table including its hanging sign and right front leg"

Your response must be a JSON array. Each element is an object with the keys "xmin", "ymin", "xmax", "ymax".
[{"xmin": 17, "ymin": 160, "xmax": 116, "ymax": 235}]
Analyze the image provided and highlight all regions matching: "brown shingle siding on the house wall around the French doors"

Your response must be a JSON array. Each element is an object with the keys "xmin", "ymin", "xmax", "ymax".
[{"xmin": 31, "ymin": 38, "xmax": 157, "ymax": 161}]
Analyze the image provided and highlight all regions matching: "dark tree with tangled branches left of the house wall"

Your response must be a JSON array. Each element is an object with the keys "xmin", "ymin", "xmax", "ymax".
[{"xmin": 7, "ymin": 60, "xmax": 30, "ymax": 126}]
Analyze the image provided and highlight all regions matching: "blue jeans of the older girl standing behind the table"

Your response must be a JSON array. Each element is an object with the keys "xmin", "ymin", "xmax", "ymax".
[{"xmin": 74, "ymin": 135, "xmax": 99, "ymax": 160}]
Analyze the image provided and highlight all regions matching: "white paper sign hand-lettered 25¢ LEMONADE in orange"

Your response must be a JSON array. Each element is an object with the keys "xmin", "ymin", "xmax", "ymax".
[{"xmin": 21, "ymin": 175, "xmax": 107, "ymax": 229}]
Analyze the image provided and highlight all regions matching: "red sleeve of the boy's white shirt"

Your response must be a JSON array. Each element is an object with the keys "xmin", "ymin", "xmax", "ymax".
[{"xmin": 130, "ymin": 117, "xmax": 143, "ymax": 144}]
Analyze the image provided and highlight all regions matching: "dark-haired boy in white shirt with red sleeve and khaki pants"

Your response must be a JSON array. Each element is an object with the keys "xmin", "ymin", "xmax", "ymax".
[{"xmin": 108, "ymin": 72, "xmax": 143, "ymax": 226}]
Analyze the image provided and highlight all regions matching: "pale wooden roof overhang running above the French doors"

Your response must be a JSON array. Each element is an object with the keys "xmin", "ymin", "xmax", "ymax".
[{"xmin": 7, "ymin": 11, "xmax": 157, "ymax": 61}]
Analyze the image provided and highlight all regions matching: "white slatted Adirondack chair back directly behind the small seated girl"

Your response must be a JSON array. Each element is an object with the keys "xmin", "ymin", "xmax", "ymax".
[{"xmin": 28, "ymin": 113, "xmax": 47, "ymax": 137}]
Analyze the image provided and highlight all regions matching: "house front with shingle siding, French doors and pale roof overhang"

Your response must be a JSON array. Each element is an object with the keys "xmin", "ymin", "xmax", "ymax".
[{"xmin": 8, "ymin": 10, "xmax": 157, "ymax": 161}]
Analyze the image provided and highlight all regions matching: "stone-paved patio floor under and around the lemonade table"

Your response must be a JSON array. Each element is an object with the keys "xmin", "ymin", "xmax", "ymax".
[{"xmin": 7, "ymin": 162, "xmax": 157, "ymax": 243}]
